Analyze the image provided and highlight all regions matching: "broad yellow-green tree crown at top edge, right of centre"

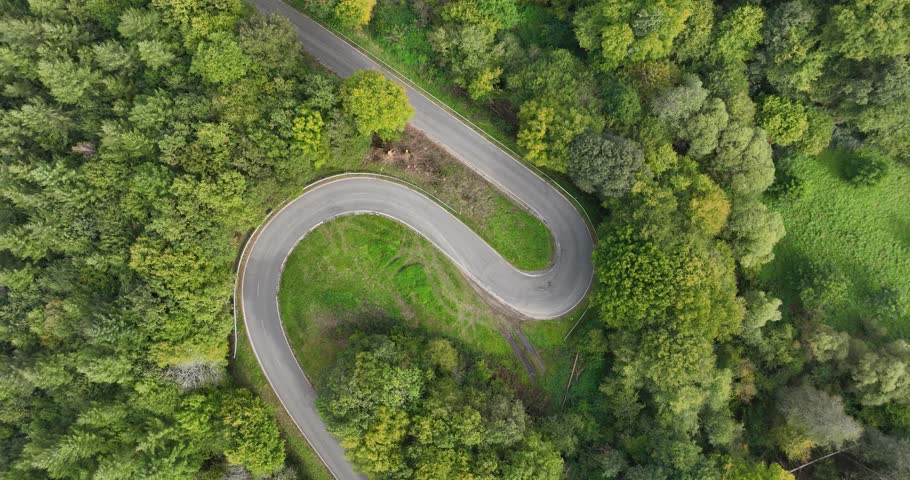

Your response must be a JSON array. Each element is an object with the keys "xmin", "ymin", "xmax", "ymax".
[{"xmin": 574, "ymin": 0, "xmax": 691, "ymax": 71}]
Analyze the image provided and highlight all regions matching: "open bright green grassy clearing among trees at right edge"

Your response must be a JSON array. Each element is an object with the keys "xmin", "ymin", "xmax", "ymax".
[{"xmin": 759, "ymin": 151, "xmax": 910, "ymax": 338}]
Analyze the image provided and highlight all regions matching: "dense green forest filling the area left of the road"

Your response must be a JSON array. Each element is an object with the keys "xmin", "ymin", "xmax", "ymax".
[{"xmin": 0, "ymin": 0, "xmax": 407, "ymax": 479}]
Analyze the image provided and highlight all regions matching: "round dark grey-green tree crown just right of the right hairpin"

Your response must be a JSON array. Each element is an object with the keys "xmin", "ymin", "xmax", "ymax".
[{"xmin": 569, "ymin": 133, "xmax": 646, "ymax": 197}]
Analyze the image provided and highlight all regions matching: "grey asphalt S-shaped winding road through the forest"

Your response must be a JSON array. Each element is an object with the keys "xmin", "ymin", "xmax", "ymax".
[{"xmin": 239, "ymin": 0, "xmax": 593, "ymax": 480}]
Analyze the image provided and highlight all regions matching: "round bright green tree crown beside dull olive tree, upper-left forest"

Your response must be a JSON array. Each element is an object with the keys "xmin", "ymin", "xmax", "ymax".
[{"xmin": 190, "ymin": 32, "xmax": 250, "ymax": 84}]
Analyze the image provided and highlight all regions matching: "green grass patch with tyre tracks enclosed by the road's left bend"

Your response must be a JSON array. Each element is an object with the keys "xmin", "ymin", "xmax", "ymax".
[{"xmin": 279, "ymin": 215, "xmax": 523, "ymax": 385}]
